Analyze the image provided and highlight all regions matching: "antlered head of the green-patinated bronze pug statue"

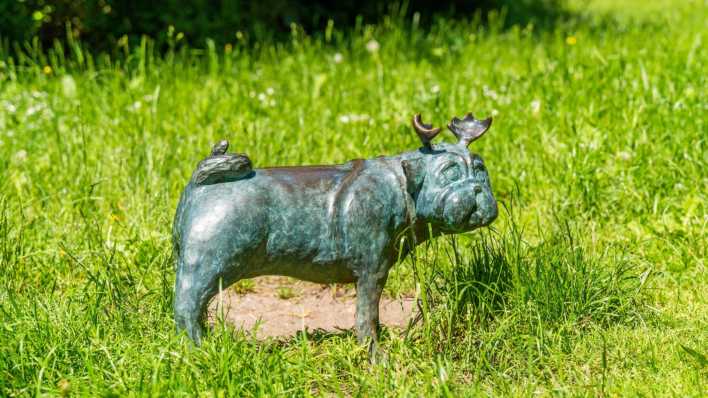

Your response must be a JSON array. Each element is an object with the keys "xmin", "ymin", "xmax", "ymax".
[{"xmin": 401, "ymin": 113, "xmax": 497, "ymax": 233}]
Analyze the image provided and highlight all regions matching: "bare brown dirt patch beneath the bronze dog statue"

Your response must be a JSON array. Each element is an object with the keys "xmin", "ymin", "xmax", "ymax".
[{"xmin": 209, "ymin": 277, "xmax": 415, "ymax": 339}]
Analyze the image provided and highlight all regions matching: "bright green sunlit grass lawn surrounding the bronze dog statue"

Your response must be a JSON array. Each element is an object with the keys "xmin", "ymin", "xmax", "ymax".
[{"xmin": 0, "ymin": 0, "xmax": 708, "ymax": 397}]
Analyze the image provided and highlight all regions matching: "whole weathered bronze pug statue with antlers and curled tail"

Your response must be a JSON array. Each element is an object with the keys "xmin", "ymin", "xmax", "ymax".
[{"xmin": 173, "ymin": 114, "xmax": 497, "ymax": 350}]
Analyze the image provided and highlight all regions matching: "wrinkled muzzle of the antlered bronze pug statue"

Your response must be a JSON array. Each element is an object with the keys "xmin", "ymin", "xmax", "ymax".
[{"xmin": 440, "ymin": 180, "xmax": 498, "ymax": 231}]
